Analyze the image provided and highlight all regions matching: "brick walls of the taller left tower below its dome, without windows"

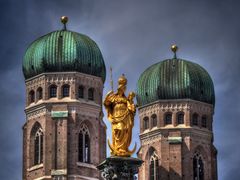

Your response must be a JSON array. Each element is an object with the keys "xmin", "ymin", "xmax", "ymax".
[{"xmin": 23, "ymin": 72, "xmax": 106, "ymax": 180}]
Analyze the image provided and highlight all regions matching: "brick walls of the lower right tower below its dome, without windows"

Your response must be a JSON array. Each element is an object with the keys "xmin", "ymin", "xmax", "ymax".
[{"xmin": 138, "ymin": 100, "xmax": 217, "ymax": 180}]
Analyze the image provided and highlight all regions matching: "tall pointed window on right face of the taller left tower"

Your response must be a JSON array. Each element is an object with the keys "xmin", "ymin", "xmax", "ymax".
[{"xmin": 78, "ymin": 124, "xmax": 90, "ymax": 163}]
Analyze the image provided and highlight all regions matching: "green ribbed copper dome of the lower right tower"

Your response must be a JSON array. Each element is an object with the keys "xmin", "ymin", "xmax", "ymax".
[{"xmin": 137, "ymin": 58, "xmax": 215, "ymax": 106}]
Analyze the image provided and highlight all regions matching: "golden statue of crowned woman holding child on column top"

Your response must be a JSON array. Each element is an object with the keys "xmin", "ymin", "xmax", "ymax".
[{"xmin": 104, "ymin": 75, "xmax": 136, "ymax": 157}]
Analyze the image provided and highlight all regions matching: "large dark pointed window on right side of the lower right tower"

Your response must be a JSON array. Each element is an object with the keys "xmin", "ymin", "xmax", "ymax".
[{"xmin": 193, "ymin": 153, "xmax": 204, "ymax": 180}]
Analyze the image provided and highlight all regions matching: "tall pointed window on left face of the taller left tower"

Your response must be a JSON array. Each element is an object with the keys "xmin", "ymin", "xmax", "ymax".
[{"xmin": 31, "ymin": 123, "xmax": 43, "ymax": 165}]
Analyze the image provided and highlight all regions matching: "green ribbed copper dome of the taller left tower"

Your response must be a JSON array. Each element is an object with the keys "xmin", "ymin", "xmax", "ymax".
[{"xmin": 23, "ymin": 30, "xmax": 106, "ymax": 82}]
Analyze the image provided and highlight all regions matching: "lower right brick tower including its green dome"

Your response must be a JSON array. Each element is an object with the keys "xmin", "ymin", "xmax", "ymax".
[{"xmin": 137, "ymin": 47, "xmax": 217, "ymax": 180}]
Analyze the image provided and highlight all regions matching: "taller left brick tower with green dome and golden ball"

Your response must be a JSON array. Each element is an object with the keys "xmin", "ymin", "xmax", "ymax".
[{"xmin": 23, "ymin": 17, "xmax": 106, "ymax": 180}]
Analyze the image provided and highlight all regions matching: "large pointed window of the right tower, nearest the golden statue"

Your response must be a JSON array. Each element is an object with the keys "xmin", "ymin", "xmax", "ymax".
[{"xmin": 149, "ymin": 151, "xmax": 159, "ymax": 180}]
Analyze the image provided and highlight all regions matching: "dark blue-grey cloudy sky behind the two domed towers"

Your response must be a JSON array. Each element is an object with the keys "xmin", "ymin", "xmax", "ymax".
[{"xmin": 0, "ymin": 0, "xmax": 240, "ymax": 180}]
